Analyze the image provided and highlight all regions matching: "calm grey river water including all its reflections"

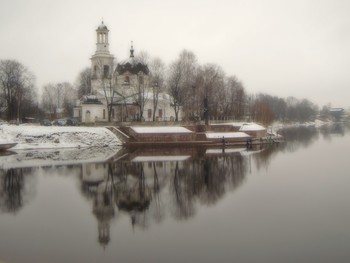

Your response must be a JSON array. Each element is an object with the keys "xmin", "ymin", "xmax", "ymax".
[{"xmin": 0, "ymin": 126, "xmax": 350, "ymax": 262}]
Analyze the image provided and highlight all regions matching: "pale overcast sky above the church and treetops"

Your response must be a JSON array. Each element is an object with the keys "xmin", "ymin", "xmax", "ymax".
[{"xmin": 0, "ymin": 0, "xmax": 350, "ymax": 108}]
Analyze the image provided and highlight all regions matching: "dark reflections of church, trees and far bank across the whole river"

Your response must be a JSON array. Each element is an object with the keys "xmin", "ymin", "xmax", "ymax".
[{"xmin": 0, "ymin": 126, "xmax": 348, "ymax": 252}]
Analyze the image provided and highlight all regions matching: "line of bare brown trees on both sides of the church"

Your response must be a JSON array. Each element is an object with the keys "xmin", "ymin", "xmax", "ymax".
[{"xmin": 0, "ymin": 53, "xmax": 340, "ymax": 125}]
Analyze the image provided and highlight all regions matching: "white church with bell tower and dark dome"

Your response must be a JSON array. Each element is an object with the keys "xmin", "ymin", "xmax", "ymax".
[{"xmin": 73, "ymin": 21, "xmax": 181, "ymax": 124}]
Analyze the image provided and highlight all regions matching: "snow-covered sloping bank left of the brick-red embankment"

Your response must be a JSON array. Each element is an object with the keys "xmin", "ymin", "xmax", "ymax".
[{"xmin": 0, "ymin": 125, "xmax": 121, "ymax": 150}]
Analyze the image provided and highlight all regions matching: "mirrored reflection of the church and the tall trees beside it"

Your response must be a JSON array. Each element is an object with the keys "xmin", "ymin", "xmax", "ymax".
[{"xmin": 81, "ymin": 148, "xmax": 261, "ymax": 249}]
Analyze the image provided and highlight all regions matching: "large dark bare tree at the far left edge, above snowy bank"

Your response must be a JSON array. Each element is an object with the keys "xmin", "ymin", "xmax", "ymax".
[{"xmin": 0, "ymin": 60, "xmax": 35, "ymax": 122}]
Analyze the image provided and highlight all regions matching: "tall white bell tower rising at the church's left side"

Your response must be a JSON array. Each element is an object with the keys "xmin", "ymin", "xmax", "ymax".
[{"xmin": 91, "ymin": 21, "xmax": 114, "ymax": 93}]
